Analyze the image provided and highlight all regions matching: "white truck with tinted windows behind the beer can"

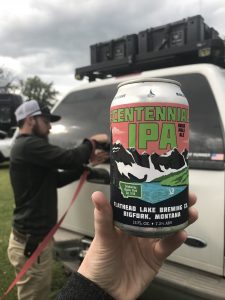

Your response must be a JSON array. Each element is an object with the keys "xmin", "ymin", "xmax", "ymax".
[{"xmin": 51, "ymin": 64, "xmax": 225, "ymax": 300}]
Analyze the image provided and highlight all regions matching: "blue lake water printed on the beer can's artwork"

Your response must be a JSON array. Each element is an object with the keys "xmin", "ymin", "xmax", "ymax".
[{"xmin": 140, "ymin": 182, "xmax": 186, "ymax": 204}]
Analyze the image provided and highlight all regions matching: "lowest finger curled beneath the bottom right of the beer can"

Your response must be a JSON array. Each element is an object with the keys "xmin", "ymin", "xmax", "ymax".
[{"xmin": 155, "ymin": 230, "xmax": 187, "ymax": 263}]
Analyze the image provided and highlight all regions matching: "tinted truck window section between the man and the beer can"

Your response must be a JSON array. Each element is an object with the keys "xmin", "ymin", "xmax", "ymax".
[{"xmin": 50, "ymin": 84, "xmax": 117, "ymax": 148}]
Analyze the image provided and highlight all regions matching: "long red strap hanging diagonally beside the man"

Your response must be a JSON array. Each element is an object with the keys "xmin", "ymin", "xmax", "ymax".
[{"xmin": 0, "ymin": 170, "xmax": 88, "ymax": 300}]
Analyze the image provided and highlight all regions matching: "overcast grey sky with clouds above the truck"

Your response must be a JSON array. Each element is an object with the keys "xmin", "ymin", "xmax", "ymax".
[{"xmin": 0, "ymin": 0, "xmax": 225, "ymax": 96}]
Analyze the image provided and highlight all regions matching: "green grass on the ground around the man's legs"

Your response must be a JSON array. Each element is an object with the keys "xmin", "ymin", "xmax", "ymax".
[{"xmin": 0, "ymin": 164, "xmax": 68, "ymax": 300}]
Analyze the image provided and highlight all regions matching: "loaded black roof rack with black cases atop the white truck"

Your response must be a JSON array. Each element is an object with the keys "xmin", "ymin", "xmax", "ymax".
[{"xmin": 75, "ymin": 15, "xmax": 225, "ymax": 81}]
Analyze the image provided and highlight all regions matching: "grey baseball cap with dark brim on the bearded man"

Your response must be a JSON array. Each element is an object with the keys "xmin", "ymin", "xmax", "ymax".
[{"xmin": 15, "ymin": 100, "xmax": 61, "ymax": 122}]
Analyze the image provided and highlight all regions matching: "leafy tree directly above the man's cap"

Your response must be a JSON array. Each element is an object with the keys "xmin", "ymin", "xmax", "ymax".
[{"xmin": 19, "ymin": 76, "xmax": 59, "ymax": 107}]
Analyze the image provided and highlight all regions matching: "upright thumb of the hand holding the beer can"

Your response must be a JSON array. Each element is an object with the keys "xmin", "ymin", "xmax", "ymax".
[{"xmin": 92, "ymin": 192, "xmax": 114, "ymax": 238}]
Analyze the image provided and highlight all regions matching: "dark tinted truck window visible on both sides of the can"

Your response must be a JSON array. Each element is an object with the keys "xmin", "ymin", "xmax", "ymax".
[{"xmin": 50, "ymin": 74, "xmax": 224, "ymax": 170}]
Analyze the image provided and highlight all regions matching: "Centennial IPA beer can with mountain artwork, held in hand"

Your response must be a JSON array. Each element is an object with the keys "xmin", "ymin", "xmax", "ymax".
[{"xmin": 110, "ymin": 78, "xmax": 189, "ymax": 237}]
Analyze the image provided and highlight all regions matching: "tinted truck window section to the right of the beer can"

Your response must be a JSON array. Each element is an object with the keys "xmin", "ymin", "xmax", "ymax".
[{"xmin": 167, "ymin": 74, "xmax": 224, "ymax": 169}]
